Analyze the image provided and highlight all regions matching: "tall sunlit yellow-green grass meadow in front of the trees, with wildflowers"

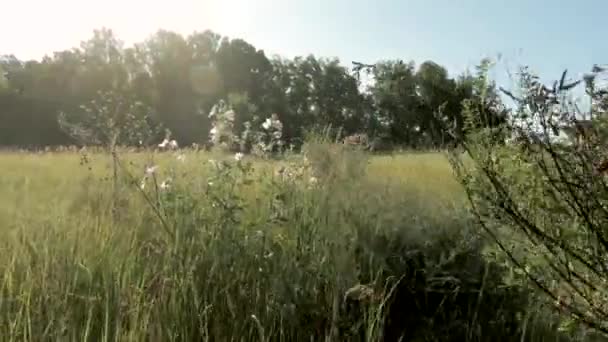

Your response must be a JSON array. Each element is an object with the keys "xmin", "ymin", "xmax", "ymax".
[{"xmin": 0, "ymin": 146, "xmax": 600, "ymax": 341}]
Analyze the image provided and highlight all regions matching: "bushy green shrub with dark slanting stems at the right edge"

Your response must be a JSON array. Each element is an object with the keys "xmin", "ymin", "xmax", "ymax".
[{"xmin": 453, "ymin": 62, "xmax": 608, "ymax": 333}]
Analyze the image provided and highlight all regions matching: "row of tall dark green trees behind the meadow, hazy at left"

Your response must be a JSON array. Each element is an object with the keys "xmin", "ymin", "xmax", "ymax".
[{"xmin": 0, "ymin": 28, "xmax": 505, "ymax": 148}]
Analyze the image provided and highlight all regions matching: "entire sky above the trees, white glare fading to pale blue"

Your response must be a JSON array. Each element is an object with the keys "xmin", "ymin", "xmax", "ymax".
[{"xmin": 0, "ymin": 0, "xmax": 608, "ymax": 88}]
